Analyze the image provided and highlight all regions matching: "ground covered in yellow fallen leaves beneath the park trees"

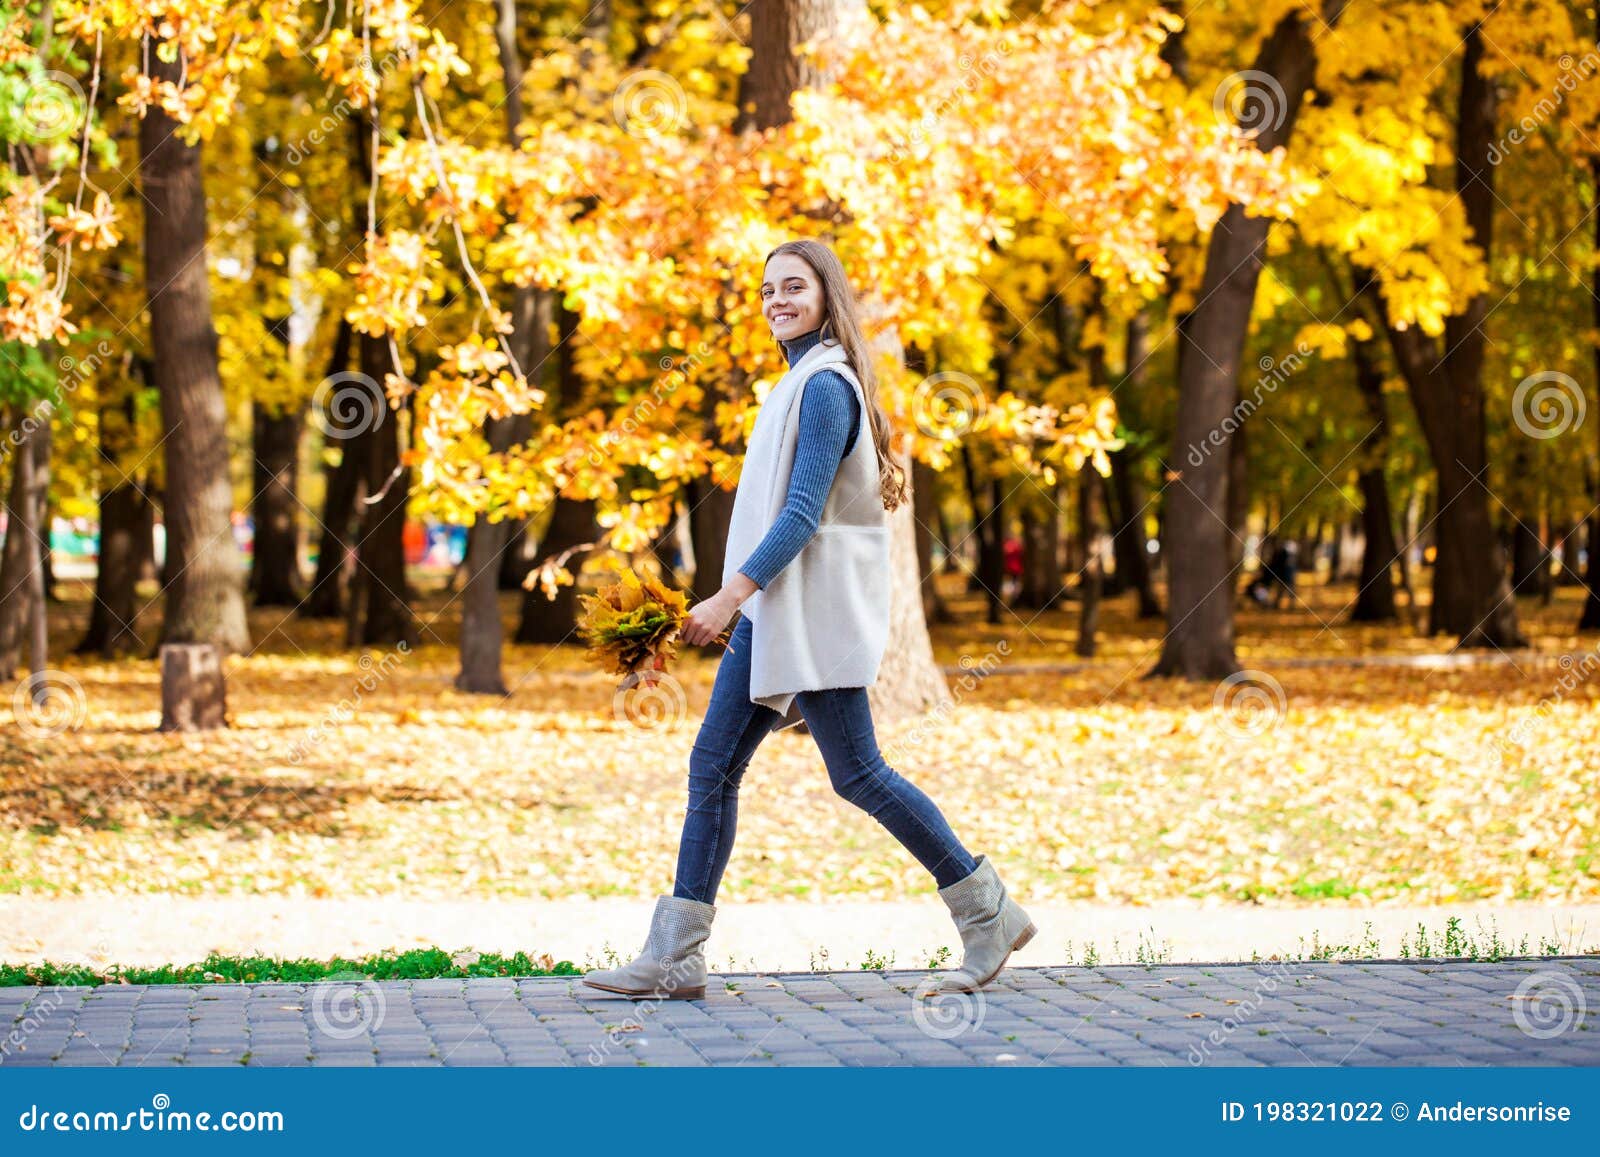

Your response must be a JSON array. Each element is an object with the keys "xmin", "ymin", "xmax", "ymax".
[{"xmin": 0, "ymin": 578, "xmax": 1600, "ymax": 904}]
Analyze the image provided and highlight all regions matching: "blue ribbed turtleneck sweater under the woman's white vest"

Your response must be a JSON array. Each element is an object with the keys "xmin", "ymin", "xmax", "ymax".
[{"xmin": 739, "ymin": 326, "xmax": 861, "ymax": 589}]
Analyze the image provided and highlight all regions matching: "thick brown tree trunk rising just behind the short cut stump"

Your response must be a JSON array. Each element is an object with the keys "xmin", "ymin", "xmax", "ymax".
[{"xmin": 139, "ymin": 42, "xmax": 250, "ymax": 651}]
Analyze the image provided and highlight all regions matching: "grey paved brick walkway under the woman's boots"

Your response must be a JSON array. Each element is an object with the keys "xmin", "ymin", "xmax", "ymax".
[{"xmin": 0, "ymin": 957, "xmax": 1600, "ymax": 1067}]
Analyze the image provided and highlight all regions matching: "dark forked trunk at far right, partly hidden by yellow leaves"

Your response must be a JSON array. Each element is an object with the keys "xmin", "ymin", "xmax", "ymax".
[{"xmin": 1378, "ymin": 24, "xmax": 1528, "ymax": 650}]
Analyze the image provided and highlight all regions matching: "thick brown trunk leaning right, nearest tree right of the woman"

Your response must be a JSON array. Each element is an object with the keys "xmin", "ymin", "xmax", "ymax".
[{"xmin": 1150, "ymin": 0, "xmax": 1344, "ymax": 679}]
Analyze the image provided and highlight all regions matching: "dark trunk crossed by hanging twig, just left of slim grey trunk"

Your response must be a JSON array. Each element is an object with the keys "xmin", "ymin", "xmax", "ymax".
[{"xmin": 349, "ymin": 333, "xmax": 418, "ymax": 647}]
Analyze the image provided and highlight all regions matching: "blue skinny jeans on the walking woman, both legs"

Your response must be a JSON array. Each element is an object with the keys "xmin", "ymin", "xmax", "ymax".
[{"xmin": 672, "ymin": 618, "xmax": 978, "ymax": 904}]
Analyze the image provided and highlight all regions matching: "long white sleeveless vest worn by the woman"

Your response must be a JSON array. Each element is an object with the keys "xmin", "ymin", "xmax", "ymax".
[{"xmin": 722, "ymin": 342, "xmax": 890, "ymax": 731}]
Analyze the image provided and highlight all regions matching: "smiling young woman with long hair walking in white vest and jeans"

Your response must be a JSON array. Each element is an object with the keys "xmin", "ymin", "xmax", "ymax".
[{"xmin": 584, "ymin": 240, "xmax": 1035, "ymax": 999}]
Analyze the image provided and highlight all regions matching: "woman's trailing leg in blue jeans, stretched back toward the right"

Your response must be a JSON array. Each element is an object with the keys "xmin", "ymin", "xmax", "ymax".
[{"xmin": 796, "ymin": 687, "xmax": 978, "ymax": 888}]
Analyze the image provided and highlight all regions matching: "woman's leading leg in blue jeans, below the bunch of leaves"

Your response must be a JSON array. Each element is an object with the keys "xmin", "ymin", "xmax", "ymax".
[{"xmin": 672, "ymin": 619, "xmax": 782, "ymax": 904}]
